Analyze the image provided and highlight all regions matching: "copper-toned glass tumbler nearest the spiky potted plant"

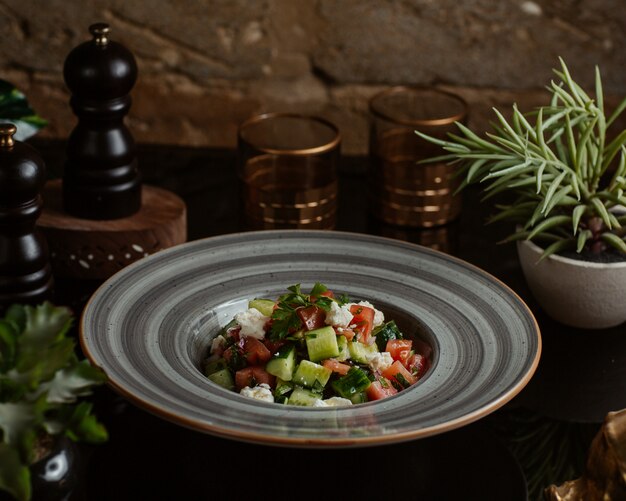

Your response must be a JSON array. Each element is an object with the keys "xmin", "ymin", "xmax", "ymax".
[{"xmin": 369, "ymin": 87, "xmax": 468, "ymax": 228}]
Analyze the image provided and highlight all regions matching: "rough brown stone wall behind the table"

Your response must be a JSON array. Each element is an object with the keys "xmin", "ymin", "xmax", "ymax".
[{"xmin": 0, "ymin": 0, "xmax": 626, "ymax": 154}]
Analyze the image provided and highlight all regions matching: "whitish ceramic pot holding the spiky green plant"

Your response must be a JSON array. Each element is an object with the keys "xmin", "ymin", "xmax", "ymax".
[{"xmin": 517, "ymin": 241, "xmax": 626, "ymax": 329}]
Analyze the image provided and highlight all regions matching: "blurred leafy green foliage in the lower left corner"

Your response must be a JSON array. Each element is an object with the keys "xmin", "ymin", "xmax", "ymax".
[{"xmin": 0, "ymin": 302, "xmax": 107, "ymax": 500}]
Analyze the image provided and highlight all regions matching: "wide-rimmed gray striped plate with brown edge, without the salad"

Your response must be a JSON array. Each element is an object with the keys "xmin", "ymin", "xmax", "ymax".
[{"xmin": 80, "ymin": 230, "xmax": 541, "ymax": 447}]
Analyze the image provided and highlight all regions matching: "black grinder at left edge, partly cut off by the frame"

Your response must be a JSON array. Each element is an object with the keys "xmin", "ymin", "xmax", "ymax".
[{"xmin": 0, "ymin": 124, "xmax": 53, "ymax": 311}]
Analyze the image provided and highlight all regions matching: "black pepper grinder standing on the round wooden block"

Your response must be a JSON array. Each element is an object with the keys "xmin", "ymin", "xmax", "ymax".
[{"xmin": 63, "ymin": 23, "xmax": 141, "ymax": 219}]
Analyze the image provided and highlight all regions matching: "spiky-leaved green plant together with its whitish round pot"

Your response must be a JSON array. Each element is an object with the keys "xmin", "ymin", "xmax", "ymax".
[{"xmin": 416, "ymin": 59, "xmax": 626, "ymax": 328}]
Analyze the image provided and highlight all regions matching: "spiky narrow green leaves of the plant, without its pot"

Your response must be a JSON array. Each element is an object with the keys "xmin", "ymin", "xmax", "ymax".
[{"xmin": 416, "ymin": 59, "xmax": 626, "ymax": 259}]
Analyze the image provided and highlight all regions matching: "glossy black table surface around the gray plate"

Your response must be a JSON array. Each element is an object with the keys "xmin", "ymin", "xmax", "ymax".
[{"xmin": 33, "ymin": 140, "xmax": 626, "ymax": 500}]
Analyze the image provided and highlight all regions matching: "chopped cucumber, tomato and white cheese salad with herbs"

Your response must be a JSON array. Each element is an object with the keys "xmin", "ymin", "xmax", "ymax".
[{"xmin": 204, "ymin": 283, "xmax": 430, "ymax": 407}]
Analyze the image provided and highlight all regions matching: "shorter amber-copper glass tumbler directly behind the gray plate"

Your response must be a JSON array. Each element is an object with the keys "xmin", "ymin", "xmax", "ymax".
[{"xmin": 238, "ymin": 113, "xmax": 341, "ymax": 229}]
